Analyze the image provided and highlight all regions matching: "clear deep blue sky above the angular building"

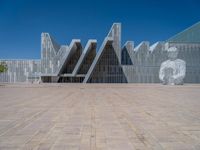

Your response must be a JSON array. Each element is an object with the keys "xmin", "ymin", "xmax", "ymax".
[{"xmin": 0, "ymin": 0, "xmax": 200, "ymax": 59}]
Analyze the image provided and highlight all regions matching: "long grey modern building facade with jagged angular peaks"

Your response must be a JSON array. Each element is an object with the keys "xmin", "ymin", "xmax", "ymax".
[{"xmin": 0, "ymin": 22, "xmax": 200, "ymax": 83}]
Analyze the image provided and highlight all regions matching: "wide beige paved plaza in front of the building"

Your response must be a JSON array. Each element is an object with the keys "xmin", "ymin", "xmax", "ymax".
[{"xmin": 0, "ymin": 84, "xmax": 200, "ymax": 150}]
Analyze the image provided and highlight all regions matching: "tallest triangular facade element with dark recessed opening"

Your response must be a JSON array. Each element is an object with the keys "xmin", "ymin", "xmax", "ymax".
[{"xmin": 83, "ymin": 23, "xmax": 126, "ymax": 83}]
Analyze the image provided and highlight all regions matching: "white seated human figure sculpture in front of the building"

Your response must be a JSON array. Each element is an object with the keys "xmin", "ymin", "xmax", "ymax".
[{"xmin": 159, "ymin": 47, "xmax": 186, "ymax": 85}]
